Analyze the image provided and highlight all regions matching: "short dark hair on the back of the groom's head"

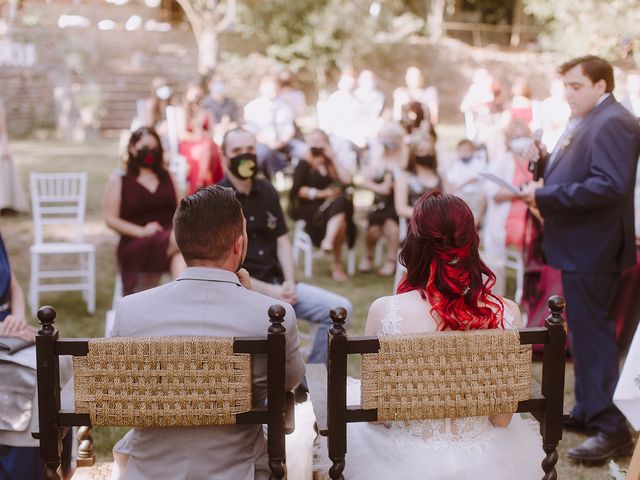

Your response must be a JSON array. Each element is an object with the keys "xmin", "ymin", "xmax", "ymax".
[{"xmin": 173, "ymin": 185, "xmax": 244, "ymax": 264}]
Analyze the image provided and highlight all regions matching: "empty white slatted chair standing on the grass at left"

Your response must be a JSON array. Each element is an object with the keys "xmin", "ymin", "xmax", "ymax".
[{"xmin": 29, "ymin": 172, "xmax": 96, "ymax": 316}]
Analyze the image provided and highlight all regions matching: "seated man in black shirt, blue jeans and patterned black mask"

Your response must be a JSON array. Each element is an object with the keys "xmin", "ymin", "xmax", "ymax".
[{"xmin": 220, "ymin": 128, "xmax": 351, "ymax": 363}]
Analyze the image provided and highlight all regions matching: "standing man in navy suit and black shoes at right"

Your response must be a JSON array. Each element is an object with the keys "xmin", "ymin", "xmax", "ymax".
[{"xmin": 522, "ymin": 56, "xmax": 640, "ymax": 462}]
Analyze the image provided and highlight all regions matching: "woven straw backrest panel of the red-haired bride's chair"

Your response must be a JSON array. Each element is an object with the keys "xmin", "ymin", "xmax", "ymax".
[{"xmin": 361, "ymin": 330, "xmax": 531, "ymax": 421}]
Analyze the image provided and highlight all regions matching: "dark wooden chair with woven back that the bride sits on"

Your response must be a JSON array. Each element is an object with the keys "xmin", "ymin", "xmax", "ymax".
[{"xmin": 307, "ymin": 296, "xmax": 566, "ymax": 480}]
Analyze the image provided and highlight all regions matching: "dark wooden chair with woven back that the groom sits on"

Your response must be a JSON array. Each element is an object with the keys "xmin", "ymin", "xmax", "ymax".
[{"xmin": 33, "ymin": 305, "xmax": 294, "ymax": 480}]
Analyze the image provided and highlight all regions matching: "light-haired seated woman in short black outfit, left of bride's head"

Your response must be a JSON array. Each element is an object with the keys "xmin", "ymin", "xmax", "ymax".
[{"xmin": 358, "ymin": 122, "xmax": 408, "ymax": 277}]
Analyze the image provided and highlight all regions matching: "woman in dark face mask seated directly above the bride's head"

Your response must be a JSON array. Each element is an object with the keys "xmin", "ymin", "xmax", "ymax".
[{"xmin": 394, "ymin": 135, "xmax": 443, "ymax": 218}]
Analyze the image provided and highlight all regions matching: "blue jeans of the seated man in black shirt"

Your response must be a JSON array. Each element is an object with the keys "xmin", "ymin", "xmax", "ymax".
[{"xmin": 293, "ymin": 283, "xmax": 353, "ymax": 363}]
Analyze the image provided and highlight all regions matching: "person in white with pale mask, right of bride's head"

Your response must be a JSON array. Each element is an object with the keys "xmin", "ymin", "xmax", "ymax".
[{"xmin": 446, "ymin": 139, "xmax": 487, "ymax": 225}]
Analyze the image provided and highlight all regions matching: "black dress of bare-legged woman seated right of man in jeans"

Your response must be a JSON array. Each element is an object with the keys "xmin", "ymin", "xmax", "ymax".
[{"xmin": 289, "ymin": 160, "xmax": 356, "ymax": 247}]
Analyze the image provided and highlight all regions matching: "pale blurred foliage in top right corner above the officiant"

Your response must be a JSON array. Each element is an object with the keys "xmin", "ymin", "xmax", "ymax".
[{"xmin": 525, "ymin": 0, "xmax": 640, "ymax": 63}]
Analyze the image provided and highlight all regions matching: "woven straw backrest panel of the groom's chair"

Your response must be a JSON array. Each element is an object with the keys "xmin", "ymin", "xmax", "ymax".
[{"xmin": 73, "ymin": 337, "xmax": 251, "ymax": 427}]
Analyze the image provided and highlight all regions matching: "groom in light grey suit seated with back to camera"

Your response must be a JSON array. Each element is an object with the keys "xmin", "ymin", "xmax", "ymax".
[{"xmin": 113, "ymin": 186, "xmax": 304, "ymax": 480}]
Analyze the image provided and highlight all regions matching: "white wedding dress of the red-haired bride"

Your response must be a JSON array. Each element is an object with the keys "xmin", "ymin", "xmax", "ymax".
[{"xmin": 316, "ymin": 296, "xmax": 545, "ymax": 480}]
